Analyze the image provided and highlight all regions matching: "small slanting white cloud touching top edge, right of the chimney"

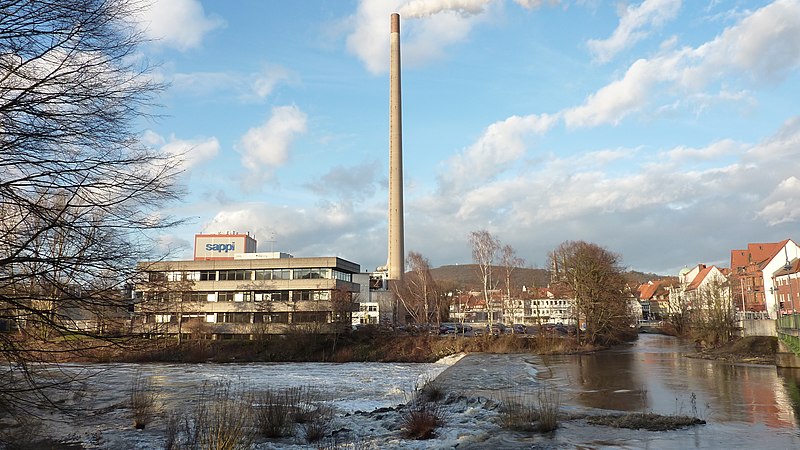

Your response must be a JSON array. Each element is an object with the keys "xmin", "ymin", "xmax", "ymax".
[{"xmin": 587, "ymin": 0, "xmax": 681, "ymax": 63}]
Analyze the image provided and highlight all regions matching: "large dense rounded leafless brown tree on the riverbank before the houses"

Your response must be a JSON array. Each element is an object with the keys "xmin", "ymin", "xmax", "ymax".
[{"xmin": 550, "ymin": 241, "xmax": 632, "ymax": 344}]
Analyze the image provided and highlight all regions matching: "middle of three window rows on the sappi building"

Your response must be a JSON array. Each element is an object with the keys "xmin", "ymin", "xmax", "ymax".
[{"xmin": 144, "ymin": 290, "xmax": 340, "ymax": 302}]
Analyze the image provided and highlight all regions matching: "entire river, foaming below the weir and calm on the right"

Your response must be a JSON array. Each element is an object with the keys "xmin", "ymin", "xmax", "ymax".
[{"xmin": 6, "ymin": 335, "xmax": 800, "ymax": 450}]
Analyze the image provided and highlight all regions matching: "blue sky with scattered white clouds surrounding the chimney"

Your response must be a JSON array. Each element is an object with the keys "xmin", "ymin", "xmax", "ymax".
[{"xmin": 139, "ymin": 0, "xmax": 800, "ymax": 274}]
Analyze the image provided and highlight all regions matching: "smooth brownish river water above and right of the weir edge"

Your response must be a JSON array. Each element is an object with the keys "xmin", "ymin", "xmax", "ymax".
[{"xmin": 440, "ymin": 335, "xmax": 800, "ymax": 449}]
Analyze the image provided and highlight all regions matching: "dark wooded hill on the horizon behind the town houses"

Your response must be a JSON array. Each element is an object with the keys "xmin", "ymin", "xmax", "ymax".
[{"xmin": 431, "ymin": 264, "xmax": 667, "ymax": 290}]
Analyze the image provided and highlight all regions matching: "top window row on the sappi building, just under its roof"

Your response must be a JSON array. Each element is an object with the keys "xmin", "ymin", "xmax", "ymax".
[{"xmin": 148, "ymin": 268, "xmax": 353, "ymax": 283}]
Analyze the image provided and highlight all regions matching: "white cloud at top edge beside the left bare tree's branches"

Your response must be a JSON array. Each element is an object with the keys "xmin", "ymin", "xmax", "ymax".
[{"xmin": 137, "ymin": 0, "xmax": 225, "ymax": 50}]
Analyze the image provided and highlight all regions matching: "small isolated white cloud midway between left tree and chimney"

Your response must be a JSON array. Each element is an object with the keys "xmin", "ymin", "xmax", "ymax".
[{"xmin": 239, "ymin": 106, "xmax": 306, "ymax": 184}]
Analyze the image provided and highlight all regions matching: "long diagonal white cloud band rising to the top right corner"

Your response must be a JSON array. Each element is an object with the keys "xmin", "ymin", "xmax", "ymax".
[{"xmin": 564, "ymin": 0, "xmax": 800, "ymax": 128}]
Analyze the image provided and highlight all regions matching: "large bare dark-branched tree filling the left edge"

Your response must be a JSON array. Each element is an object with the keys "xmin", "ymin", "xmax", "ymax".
[{"xmin": 0, "ymin": 0, "xmax": 181, "ymax": 420}]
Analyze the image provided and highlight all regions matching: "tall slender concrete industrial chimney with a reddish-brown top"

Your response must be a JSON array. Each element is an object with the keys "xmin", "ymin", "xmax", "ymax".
[{"xmin": 387, "ymin": 13, "xmax": 405, "ymax": 280}]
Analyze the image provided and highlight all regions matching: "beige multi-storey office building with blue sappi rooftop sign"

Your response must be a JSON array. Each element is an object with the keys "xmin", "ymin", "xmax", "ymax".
[{"xmin": 134, "ymin": 233, "xmax": 360, "ymax": 339}]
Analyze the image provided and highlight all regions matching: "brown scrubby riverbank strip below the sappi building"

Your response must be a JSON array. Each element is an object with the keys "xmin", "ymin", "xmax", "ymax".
[{"xmin": 42, "ymin": 329, "xmax": 597, "ymax": 363}]
